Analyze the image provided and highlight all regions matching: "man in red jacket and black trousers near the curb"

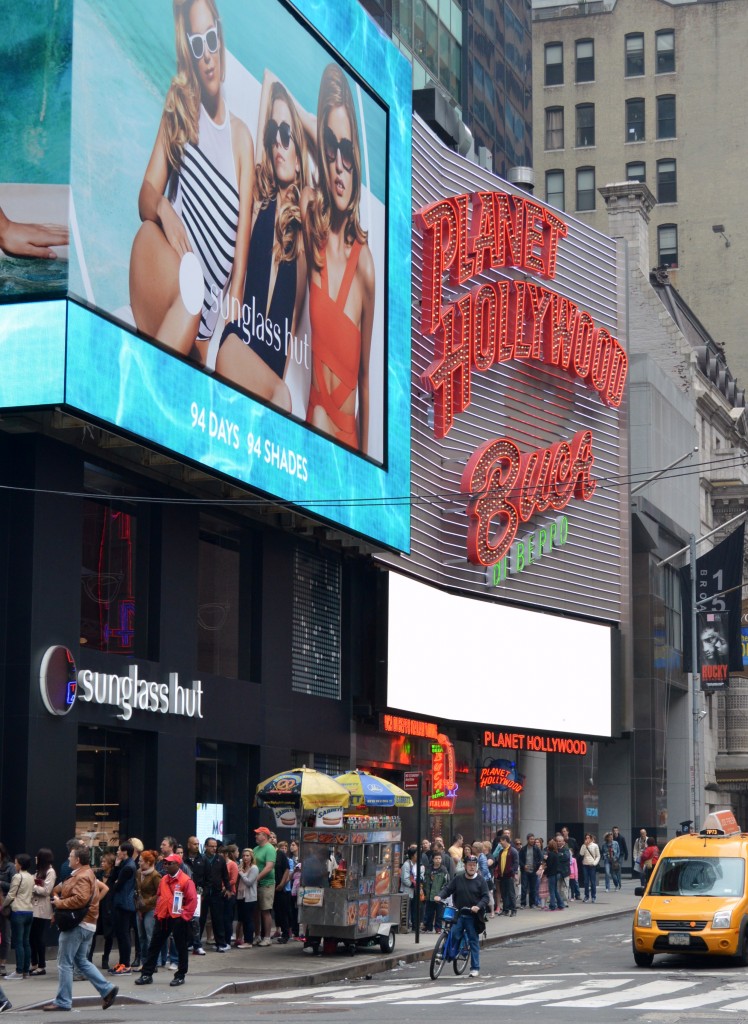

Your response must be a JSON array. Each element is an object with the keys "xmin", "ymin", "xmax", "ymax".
[{"xmin": 135, "ymin": 853, "xmax": 198, "ymax": 987}]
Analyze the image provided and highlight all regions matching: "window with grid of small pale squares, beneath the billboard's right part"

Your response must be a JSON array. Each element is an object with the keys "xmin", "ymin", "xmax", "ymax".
[{"xmin": 291, "ymin": 548, "xmax": 342, "ymax": 700}]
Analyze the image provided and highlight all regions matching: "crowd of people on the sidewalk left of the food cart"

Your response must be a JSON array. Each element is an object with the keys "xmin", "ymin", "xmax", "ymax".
[{"xmin": 0, "ymin": 826, "xmax": 301, "ymax": 1013}]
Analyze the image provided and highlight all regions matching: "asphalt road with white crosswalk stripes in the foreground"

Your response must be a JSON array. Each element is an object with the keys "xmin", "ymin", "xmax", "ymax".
[{"xmin": 21, "ymin": 918, "xmax": 748, "ymax": 1024}]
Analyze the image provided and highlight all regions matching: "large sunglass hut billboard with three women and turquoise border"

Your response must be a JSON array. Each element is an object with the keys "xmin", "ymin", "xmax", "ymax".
[{"xmin": 0, "ymin": 0, "xmax": 411, "ymax": 550}]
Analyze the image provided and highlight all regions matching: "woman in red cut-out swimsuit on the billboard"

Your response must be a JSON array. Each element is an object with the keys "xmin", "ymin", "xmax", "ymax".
[{"xmin": 301, "ymin": 63, "xmax": 375, "ymax": 453}]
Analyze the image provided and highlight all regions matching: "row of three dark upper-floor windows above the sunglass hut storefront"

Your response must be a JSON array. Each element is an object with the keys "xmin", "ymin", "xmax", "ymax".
[{"xmin": 80, "ymin": 500, "xmax": 342, "ymax": 699}]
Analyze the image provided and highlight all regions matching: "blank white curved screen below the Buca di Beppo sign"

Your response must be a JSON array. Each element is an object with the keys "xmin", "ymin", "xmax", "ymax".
[{"xmin": 387, "ymin": 572, "xmax": 611, "ymax": 736}]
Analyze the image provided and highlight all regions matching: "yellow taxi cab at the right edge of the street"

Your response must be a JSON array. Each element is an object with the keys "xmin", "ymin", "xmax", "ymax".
[{"xmin": 632, "ymin": 810, "xmax": 748, "ymax": 967}]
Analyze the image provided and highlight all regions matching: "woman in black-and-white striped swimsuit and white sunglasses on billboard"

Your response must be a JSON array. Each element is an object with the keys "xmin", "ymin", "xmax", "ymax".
[{"xmin": 130, "ymin": 0, "xmax": 254, "ymax": 362}]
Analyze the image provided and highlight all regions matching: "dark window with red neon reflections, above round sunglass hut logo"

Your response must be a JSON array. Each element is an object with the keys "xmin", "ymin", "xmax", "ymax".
[{"xmin": 81, "ymin": 501, "xmax": 137, "ymax": 654}]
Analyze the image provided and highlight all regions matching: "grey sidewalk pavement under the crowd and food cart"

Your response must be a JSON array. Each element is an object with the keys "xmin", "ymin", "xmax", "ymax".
[{"xmin": 2, "ymin": 879, "xmax": 638, "ymax": 1011}]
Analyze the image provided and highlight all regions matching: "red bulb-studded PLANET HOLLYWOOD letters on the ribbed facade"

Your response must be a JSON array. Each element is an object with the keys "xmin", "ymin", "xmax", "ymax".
[{"xmin": 415, "ymin": 193, "xmax": 628, "ymax": 437}]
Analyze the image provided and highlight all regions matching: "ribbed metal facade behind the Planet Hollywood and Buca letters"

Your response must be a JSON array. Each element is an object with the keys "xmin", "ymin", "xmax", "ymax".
[{"xmin": 375, "ymin": 119, "xmax": 628, "ymax": 623}]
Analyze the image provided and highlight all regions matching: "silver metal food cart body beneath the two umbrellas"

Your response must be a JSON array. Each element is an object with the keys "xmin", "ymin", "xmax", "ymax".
[{"xmin": 298, "ymin": 813, "xmax": 403, "ymax": 955}]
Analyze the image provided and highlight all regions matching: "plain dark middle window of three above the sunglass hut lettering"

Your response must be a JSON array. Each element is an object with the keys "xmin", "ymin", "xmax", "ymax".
[{"xmin": 198, "ymin": 516, "xmax": 237, "ymax": 679}]
